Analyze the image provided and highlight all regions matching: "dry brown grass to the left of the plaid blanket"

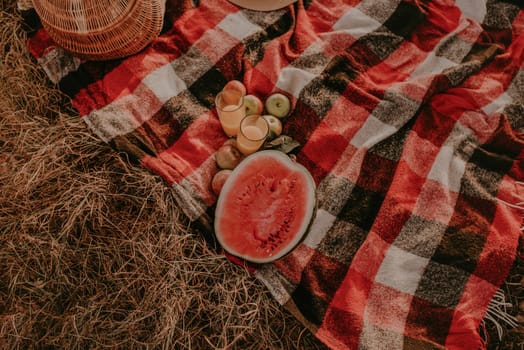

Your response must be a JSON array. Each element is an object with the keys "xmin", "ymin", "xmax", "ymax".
[{"xmin": 0, "ymin": 0, "xmax": 328, "ymax": 349}]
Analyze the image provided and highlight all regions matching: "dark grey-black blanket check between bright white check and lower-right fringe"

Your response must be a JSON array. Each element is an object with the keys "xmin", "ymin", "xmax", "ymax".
[{"xmin": 415, "ymin": 260, "xmax": 470, "ymax": 309}]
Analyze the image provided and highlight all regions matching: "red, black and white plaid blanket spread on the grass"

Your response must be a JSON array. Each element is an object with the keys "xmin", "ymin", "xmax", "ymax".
[{"xmin": 23, "ymin": 0, "xmax": 524, "ymax": 349}]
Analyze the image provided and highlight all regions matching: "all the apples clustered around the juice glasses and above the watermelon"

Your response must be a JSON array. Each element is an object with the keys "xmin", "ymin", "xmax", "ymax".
[{"xmin": 211, "ymin": 80, "xmax": 291, "ymax": 195}]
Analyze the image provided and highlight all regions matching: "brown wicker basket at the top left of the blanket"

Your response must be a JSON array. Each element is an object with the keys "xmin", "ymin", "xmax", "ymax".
[{"xmin": 33, "ymin": 0, "xmax": 165, "ymax": 60}]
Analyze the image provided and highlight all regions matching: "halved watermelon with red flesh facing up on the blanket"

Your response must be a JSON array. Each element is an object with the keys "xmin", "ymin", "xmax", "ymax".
[{"xmin": 214, "ymin": 150, "xmax": 316, "ymax": 263}]
